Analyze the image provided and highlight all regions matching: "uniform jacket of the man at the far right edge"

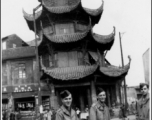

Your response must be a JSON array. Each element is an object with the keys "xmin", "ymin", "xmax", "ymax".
[{"xmin": 137, "ymin": 94, "xmax": 150, "ymax": 120}]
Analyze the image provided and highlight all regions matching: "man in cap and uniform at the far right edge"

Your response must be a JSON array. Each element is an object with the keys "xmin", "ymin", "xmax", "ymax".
[{"xmin": 137, "ymin": 83, "xmax": 150, "ymax": 120}]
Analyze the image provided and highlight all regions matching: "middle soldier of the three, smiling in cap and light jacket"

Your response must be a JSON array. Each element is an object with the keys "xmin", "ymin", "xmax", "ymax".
[{"xmin": 89, "ymin": 88, "xmax": 110, "ymax": 120}]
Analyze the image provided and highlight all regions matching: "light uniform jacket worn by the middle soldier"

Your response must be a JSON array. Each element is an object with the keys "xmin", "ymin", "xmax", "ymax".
[{"xmin": 89, "ymin": 101, "xmax": 110, "ymax": 120}]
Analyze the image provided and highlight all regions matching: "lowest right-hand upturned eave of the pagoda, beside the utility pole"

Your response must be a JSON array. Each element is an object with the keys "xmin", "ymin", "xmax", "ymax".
[{"xmin": 100, "ymin": 58, "xmax": 131, "ymax": 77}]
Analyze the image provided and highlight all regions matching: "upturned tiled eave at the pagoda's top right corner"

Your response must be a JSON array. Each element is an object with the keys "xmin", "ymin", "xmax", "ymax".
[{"xmin": 83, "ymin": 0, "xmax": 104, "ymax": 16}]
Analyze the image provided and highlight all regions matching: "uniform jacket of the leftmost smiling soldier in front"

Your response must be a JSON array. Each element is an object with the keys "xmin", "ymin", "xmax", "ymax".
[{"xmin": 55, "ymin": 106, "xmax": 79, "ymax": 120}]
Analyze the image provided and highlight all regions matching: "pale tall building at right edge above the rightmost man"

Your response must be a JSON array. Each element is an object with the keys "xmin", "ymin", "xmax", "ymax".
[{"xmin": 142, "ymin": 49, "xmax": 150, "ymax": 84}]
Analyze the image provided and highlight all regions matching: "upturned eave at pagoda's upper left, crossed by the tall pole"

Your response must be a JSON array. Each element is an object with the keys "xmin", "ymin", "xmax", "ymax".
[{"xmin": 22, "ymin": 9, "xmax": 42, "ymax": 21}]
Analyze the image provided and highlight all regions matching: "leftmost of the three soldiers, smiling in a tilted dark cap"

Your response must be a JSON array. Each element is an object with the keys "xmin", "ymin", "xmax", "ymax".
[{"xmin": 55, "ymin": 90, "xmax": 79, "ymax": 120}]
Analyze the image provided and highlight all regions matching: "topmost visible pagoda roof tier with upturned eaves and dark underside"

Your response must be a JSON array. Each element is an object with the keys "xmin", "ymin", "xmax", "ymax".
[{"xmin": 23, "ymin": 0, "xmax": 104, "ymax": 28}]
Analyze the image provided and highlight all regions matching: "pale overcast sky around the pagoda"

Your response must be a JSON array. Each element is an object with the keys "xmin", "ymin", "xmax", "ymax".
[{"xmin": 1, "ymin": 0, "xmax": 151, "ymax": 86}]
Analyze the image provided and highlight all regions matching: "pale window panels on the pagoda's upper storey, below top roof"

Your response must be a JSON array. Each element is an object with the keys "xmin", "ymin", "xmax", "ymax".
[{"xmin": 55, "ymin": 23, "xmax": 74, "ymax": 34}]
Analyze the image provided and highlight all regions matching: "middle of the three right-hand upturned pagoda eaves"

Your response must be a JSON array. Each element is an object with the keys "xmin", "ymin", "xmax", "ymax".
[{"xmin": 91, "ymin": 27, "xmax": 115, "ymax": 44}]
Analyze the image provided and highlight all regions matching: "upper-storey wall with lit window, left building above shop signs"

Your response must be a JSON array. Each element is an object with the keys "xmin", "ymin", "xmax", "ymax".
[{"xmin": 2, "ymin": 58, "xmax": 37, "ymax": 91}]
